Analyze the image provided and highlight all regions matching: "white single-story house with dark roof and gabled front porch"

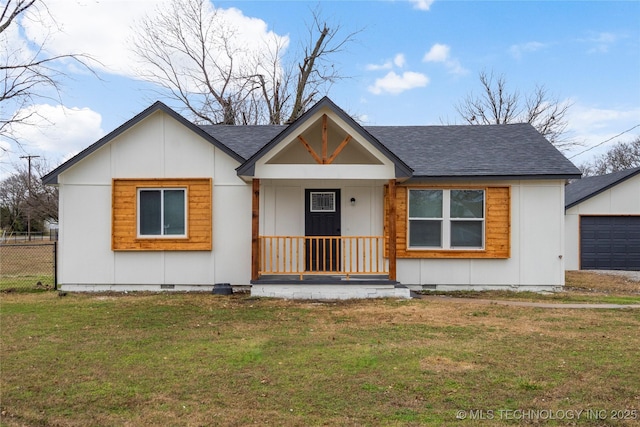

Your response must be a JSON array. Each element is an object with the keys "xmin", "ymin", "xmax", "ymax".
[{"xmin": 43, "ymin": 98, "xmax": 580, "ymax": 298}]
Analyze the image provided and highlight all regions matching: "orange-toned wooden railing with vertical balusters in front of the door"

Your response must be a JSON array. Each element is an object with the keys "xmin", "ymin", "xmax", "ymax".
[{"xmin": 259, "ymin": 236, "xmax": 389, "ymax": 279}]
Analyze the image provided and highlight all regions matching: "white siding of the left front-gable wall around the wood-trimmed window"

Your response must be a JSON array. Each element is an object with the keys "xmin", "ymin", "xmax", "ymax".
[{"xmin": 58, "ymin": 112, "xmax": 251, "ymax": 290}]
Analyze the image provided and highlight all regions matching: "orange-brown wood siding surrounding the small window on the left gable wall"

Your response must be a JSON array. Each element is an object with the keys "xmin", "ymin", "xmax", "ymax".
[{"xmin": 111, "ymin": 178, "xmax": 212, "ymax": 251}]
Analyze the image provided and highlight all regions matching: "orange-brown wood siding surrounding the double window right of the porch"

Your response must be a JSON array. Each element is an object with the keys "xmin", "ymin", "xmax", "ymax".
[{"xmin": 385, "ymin": 185, "xmax": 511, "ymax": 259}]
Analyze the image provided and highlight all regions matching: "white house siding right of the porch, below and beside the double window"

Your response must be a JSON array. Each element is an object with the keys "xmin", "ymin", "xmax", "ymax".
[{"xmin": 397, "ymin": 180, "xmax": 564, "ymax": 291}]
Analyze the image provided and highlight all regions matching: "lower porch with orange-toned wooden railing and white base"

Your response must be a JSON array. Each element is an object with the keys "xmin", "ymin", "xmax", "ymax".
[{"xmin": 251, "ymin": 236, "xmax": 410, "ymax": 299}]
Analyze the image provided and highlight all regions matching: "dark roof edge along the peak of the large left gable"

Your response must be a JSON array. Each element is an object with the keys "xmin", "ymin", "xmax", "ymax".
[{"xmin": 42, "ymin": 101, "xmax": 244, "ymax": 184}]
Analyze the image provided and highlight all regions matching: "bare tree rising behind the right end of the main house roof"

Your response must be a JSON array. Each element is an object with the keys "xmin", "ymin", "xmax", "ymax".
[{"xmin": 455, "ymin": 71, "xmax": 578, "ymax": 150}]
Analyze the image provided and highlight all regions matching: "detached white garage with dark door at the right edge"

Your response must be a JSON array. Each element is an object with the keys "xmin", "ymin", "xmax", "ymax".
[{"xmin": 565, "ymin": 167, "xmax": 640, "ymax": 271}]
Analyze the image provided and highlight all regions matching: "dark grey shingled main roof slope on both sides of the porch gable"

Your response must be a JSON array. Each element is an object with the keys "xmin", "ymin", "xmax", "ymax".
[{"xmin": 201, "ymin": 123, "xmax": 580, "ymax": 178}]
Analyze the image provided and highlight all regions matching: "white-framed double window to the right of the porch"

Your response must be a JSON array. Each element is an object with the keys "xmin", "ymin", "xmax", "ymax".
[{"xmin": 408, "ymin": 189, "xmax": 485, "ymax": 249}]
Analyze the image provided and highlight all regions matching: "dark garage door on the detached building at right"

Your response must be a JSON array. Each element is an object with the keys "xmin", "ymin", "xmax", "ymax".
[{"xmin": 580, "ymin": 216, "xmax": 640, "ymax": 271}]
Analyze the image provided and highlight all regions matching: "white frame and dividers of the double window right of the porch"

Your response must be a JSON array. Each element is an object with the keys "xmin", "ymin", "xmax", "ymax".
[{"xmin": 407, "ymin": 188, "xmax": 487, "ymax": 251}]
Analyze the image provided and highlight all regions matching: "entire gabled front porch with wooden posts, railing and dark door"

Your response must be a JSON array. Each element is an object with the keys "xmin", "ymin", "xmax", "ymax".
[{"xmin": 238, "ymin": 104, "xmax": 402, "ymax": 299}]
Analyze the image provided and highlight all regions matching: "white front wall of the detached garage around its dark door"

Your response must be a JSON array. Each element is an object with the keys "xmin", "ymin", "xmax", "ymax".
[{"xmin": 565, "ymin": 175, "xmax": 640, "ymax": 270}]
